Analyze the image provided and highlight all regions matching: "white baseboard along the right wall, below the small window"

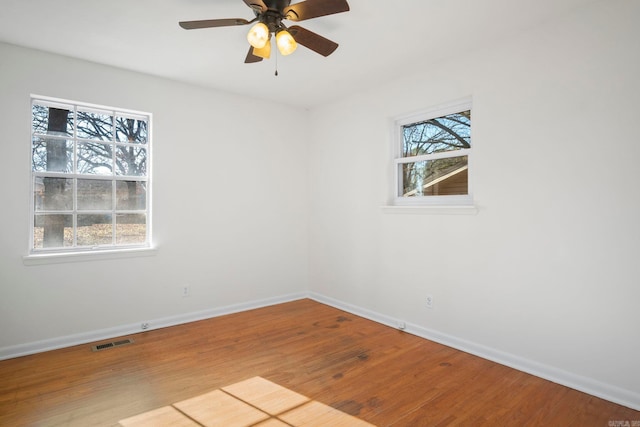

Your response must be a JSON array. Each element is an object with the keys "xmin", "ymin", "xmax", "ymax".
[{"xmin": 308, "ymin": 292, "xmax": 640, "ymax": 411}]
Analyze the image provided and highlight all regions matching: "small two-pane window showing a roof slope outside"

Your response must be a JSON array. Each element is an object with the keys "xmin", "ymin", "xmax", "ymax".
[{"xmin": 394, "ymin": 102, "xmax": 472, "ymax": 205}]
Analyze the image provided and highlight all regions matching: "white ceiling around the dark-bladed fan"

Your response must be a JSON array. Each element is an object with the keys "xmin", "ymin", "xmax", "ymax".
[{"xmin": 0, "ymin": 0, "xmax": 596, "ymax": 107}]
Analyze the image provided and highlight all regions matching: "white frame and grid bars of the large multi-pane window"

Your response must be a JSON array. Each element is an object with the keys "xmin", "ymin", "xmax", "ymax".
[{"xmin": 24, "ymin": 95, "xmax": 155, "ymax": 265}]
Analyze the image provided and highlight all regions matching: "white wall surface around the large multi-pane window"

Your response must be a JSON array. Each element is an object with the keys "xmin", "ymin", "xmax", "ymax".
[{"xmin": 0, "ymin": 44, "xmax": 308, "ymax": 355}]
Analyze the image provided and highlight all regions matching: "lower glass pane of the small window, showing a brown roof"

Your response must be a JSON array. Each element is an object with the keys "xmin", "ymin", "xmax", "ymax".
[{"xmin": 400, "ymin": 156, "xmax": 469, "ymax": 197}]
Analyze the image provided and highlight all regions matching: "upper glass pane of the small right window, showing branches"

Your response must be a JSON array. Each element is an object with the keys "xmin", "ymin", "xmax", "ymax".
[{"xmin": 402, "ymin": 110, "xmax": 471, "ymax": 157}]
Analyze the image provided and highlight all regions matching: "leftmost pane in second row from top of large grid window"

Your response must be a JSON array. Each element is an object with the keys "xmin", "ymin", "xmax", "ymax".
[{"xmin": 31, "ymin": 137, "xmax": 73, "ymax": 173}]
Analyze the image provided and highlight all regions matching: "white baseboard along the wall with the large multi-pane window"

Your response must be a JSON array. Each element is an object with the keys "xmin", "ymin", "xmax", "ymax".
[{"xmin": 0, "ymin": 292, "xmax": 308, "ymax": 360}]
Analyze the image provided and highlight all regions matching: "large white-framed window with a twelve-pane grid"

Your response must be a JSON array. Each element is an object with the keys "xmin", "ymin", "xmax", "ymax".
[{"xmin": 30, "ymin": 97, "xmax": 151, "ymax": 253}]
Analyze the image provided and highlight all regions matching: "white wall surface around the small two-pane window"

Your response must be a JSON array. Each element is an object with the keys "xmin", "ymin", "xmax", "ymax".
[{"xmin": 309, "ymin": 1, "xmax": 640, "ymax": 407}]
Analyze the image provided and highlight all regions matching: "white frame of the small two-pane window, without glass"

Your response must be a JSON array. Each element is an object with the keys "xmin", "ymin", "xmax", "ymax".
[{"xmin": 390, "ymin": 98, "xmax": 475, "ymax": 213}]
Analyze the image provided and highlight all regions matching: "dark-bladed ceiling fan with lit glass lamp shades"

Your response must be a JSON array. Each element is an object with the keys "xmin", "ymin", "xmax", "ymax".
[{"xmin": 179, "ymin": 0, "xmax": 349, "ymax": 63}]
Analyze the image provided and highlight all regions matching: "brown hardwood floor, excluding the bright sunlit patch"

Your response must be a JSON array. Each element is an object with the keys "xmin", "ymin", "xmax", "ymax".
[{"xmin": 0, "ymin": 300, "xmax": 640, "ymax": 427}]
